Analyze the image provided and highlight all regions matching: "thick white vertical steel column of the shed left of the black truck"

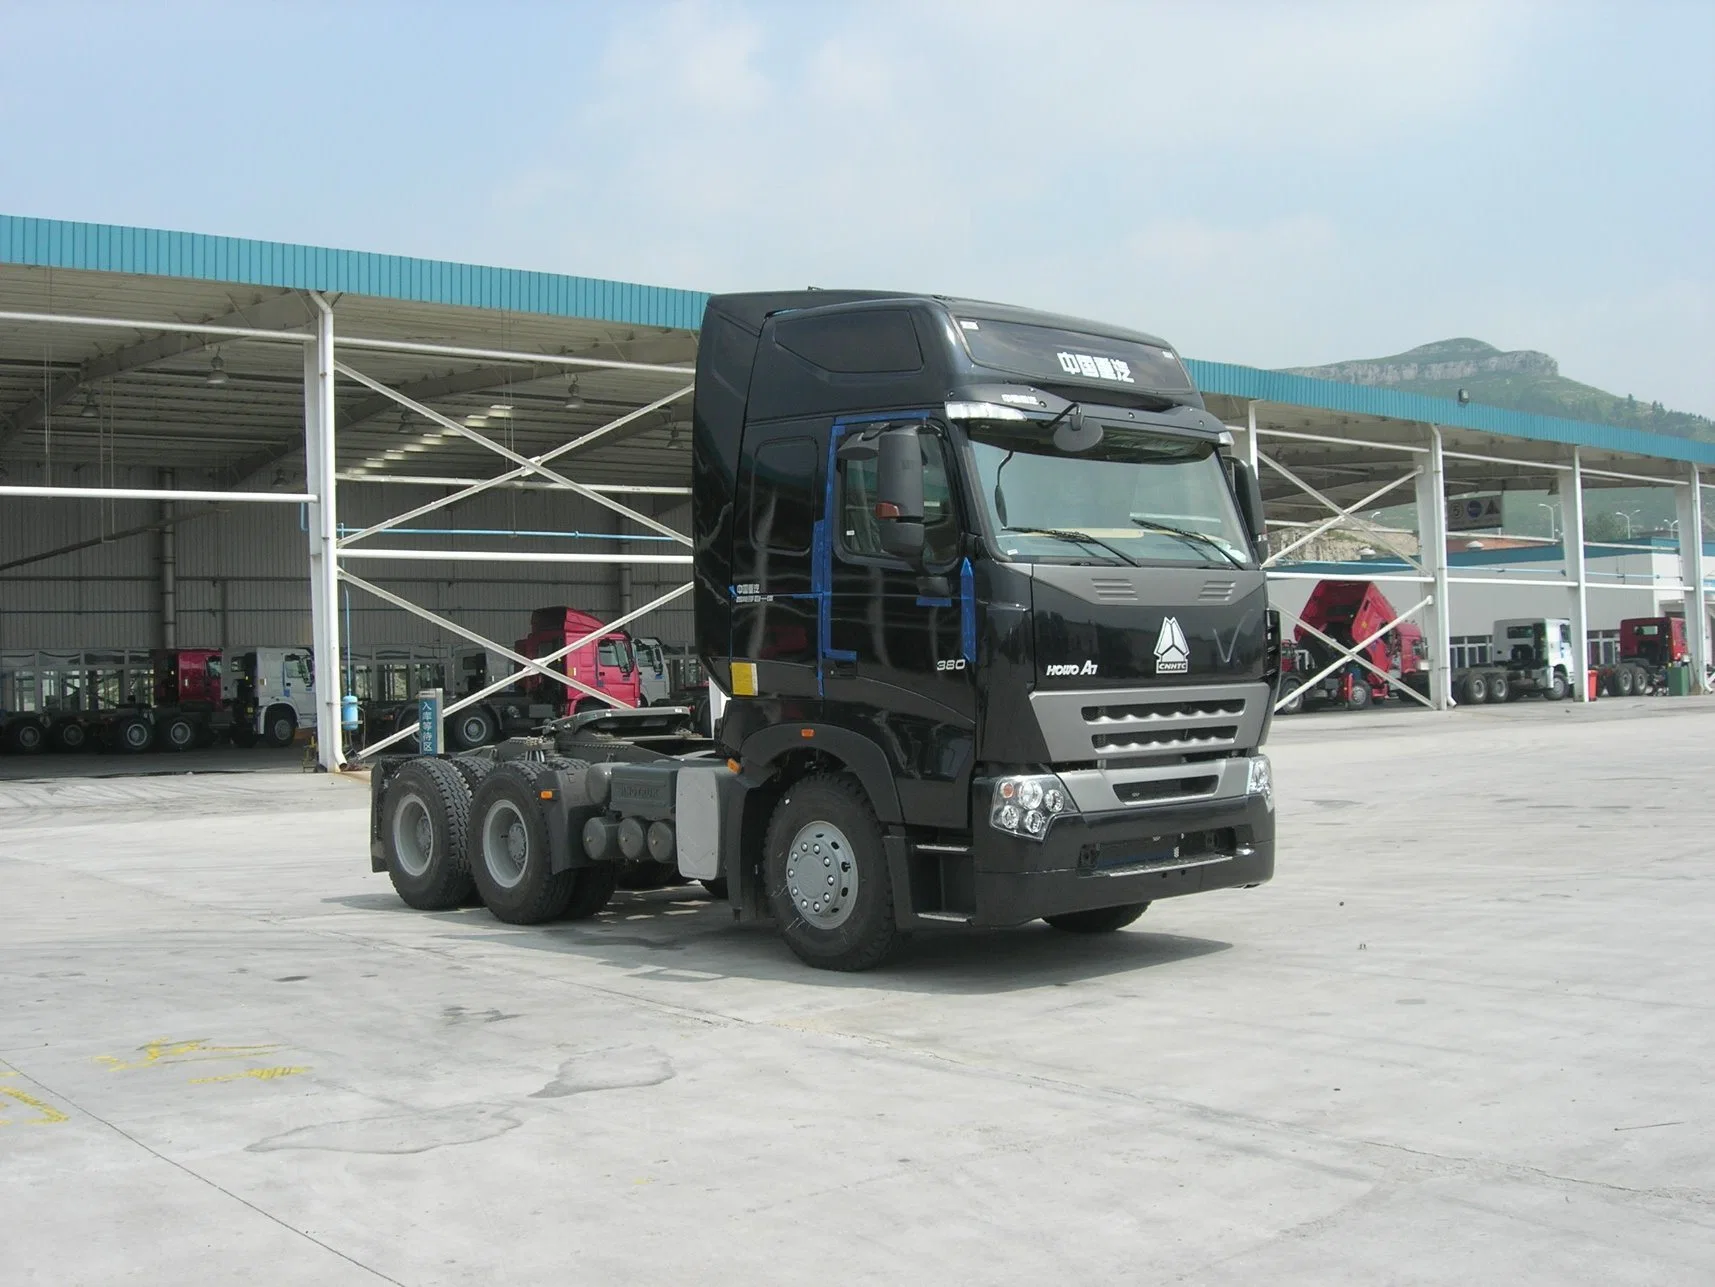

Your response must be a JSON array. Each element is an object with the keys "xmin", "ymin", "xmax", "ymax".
[{"xmin": 304, "ymin": 293, "xmax": 345, "ymax": 772}]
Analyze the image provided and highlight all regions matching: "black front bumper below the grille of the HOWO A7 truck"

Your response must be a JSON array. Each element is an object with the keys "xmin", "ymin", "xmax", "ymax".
[{"xmin": 971, "ymin": 795, "xmax": 1274, "ymax": 925}]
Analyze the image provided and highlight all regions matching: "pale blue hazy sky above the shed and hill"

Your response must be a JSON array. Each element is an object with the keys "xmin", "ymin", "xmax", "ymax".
[{"xmin": 0, "ymin": 0, "xmax": 1715, "ymax": 415}]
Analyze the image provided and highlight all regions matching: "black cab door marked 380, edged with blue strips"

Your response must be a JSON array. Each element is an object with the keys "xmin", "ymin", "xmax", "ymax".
[{"xmin": 821, "ymin": 426, "xmax": 976, "ymax": 829}]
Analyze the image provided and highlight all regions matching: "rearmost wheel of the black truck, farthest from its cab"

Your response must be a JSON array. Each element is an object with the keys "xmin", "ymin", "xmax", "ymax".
[{"xmin": 381, "ymin": 760, "xmax": 472, "ymax": 911}]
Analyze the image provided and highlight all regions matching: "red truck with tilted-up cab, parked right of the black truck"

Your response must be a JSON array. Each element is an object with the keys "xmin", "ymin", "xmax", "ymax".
[{"xmin": 1279, "ymin": 580, "xmax": 1429, "ymax": 716}]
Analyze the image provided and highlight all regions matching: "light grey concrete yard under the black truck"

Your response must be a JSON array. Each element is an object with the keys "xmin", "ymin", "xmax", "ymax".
[{"xmin": 0, "ymin": 700, "xmax": 1715, "ymax": 1287}]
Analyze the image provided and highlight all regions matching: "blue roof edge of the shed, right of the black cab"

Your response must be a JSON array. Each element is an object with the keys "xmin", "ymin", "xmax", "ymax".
[{"xmin": 1185, "ymin": 359, "xmax": 1715, "ymax": 465}]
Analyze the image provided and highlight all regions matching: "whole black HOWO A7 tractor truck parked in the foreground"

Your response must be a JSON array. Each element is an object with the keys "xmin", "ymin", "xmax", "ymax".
[{"xmin": 370, "ymin": 290, "xmax": 1279, "ymax": 970}]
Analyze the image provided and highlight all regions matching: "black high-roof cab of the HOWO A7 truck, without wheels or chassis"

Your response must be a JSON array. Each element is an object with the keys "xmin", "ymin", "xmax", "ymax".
[{"xmin": 693, "ymin": 292, "xmax": 1278, "ymax": 947}]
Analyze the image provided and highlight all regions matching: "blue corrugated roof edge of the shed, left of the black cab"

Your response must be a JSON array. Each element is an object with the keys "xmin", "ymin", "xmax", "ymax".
[{"xmin": 0, "ymin": 215, "xmax": 708, "ymax": 329}]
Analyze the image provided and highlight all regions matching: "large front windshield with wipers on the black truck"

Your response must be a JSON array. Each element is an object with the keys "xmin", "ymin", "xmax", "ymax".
[{"xmin": 969, "ymin": 426, "xmax": 1252, "ymax": 566}]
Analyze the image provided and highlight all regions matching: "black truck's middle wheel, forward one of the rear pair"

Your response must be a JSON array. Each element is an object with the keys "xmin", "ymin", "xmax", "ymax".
[{"xmin": 468, "ymin": 760, "xmax": 578, "ymax": 925}]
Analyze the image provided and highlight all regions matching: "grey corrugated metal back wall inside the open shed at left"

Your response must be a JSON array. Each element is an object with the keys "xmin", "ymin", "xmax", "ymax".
[{"xmin": 0, "ymin": 470, "xmax": 691, "ymax": 652}]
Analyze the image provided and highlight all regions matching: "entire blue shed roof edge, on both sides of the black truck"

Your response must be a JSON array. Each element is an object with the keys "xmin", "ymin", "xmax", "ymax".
[{"xmin": 0, "ymin": 215, "xmax": 1715, "ymax": 465}]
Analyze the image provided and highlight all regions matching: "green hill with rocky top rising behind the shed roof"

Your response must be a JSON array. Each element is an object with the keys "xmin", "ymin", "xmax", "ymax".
[{"xmin": 1288, "ymin": 340, "xmax": 1715, "ymax": 441}]
